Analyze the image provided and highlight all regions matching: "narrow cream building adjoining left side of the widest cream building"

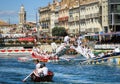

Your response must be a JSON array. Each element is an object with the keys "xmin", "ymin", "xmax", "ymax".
[{"xmin": 68, "ymin": 0, "xmax": 80, "ymax": 35}]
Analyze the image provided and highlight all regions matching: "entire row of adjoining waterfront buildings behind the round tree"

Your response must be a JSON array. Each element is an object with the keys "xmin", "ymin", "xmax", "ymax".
[{"xmin": 39, "ymin": 0, "xmax": 120, "ymax": 35}]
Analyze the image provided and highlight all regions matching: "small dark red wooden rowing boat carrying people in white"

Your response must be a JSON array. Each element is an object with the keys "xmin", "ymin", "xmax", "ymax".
[{"xmin": 31, "ymin": 71, "xmax": 54, "ymax": 82}]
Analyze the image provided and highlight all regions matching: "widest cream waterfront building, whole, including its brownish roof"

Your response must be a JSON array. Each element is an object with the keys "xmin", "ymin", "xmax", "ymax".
[{"xmin": 80, "ymin": 0, "xmax": 102, "ymax": 34}]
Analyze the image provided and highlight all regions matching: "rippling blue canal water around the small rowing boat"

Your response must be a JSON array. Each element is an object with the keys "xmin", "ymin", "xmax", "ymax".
[{"xmin": 0, "ymin": 55, "xmax": 120, "ymax": 84}]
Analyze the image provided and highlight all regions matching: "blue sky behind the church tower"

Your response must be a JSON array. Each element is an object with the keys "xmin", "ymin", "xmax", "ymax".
[{"xmin": 0, "ymin": 0, "xmax": 53, "ymax": 24}]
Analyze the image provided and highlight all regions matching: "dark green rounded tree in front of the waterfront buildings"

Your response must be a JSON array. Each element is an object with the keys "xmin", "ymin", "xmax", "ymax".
[{"xmin": 52, "ymin": 27, "xmax": 67, "ymax": 36}]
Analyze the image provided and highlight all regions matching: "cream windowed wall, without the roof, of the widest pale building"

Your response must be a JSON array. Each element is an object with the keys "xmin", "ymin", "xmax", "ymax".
[{"xmin": 80, "ymin": 3, "xmax": 102, "ymax": 32}]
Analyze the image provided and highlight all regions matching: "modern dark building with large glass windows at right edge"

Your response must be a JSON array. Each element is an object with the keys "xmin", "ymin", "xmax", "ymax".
[{"xmin": 108, "ymin": 0, "xmax": 120, "ymax": 32}]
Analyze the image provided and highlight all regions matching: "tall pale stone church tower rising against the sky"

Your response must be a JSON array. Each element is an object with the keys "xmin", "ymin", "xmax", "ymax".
[{"xmin": 19, "ymin": 5, "xmax": 26, "ymax": 28}]
